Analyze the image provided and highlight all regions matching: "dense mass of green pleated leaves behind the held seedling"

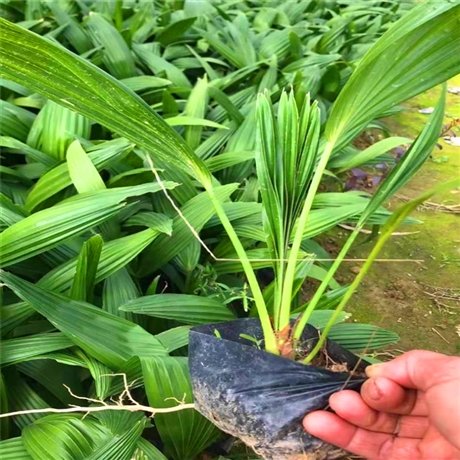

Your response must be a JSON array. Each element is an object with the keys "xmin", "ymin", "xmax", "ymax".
[{"xmin": 0, "ymin": 0, "xmax": 456, "ymax": 460}]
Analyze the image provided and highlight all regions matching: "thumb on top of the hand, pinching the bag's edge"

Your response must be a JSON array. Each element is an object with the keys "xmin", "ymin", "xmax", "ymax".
[{"xmin": 366, "ymin": 350, "xmax": 460, "ymax": 392}]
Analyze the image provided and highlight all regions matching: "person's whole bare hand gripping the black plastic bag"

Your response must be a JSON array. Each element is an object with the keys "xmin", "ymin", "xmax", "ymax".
[{"xmin": 303, "ymin": 351, "xmax": 460, "ymax": 460}]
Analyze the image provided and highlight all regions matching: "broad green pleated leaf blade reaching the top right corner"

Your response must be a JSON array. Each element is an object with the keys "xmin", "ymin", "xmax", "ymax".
[{"xmin": 326, "ymin": 0, "xmax": 460, "ymax": 142}]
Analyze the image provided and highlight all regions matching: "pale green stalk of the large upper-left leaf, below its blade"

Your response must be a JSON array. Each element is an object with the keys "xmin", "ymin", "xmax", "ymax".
[{"xmin": 206, "ymin": 186, "xmax": 279, "ymax": 355}]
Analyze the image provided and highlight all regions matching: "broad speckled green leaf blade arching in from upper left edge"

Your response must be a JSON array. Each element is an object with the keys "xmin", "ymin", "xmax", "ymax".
[{"xmin": 0, "ymin": 19, "xmax": 210, "ymax": 184}]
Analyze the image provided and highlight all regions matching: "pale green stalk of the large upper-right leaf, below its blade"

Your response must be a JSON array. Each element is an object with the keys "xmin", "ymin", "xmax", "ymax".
[{"xmin": 279, "ymin": 141, "xmax": 335, "ymax": 330}]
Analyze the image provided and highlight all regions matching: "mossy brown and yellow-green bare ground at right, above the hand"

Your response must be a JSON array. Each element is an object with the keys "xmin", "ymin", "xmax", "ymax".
[{"xmin": 331, "ymin": 76, "xmax": 460, "ymax": 354}]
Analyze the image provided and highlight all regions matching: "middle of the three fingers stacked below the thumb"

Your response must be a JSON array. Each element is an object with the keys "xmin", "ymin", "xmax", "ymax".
[{"xmin": 329, "ymin": 390, "xmax": 428, "ymax": 439}]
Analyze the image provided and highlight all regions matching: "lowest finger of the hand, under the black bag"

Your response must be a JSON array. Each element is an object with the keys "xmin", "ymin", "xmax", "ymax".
[{"xmin": 303, "ymin": 411, "xmax": 420, "ymax": 460}]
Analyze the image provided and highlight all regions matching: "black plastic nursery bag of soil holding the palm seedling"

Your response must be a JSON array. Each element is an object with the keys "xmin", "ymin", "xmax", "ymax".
[{"xmin": 189, "ymin": 318, "xmax": 367, "ymax": 460}]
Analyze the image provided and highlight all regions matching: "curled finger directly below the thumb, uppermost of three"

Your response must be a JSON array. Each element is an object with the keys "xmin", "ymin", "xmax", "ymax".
[{"xmin": 361, "ymin": 377, "xmax": 428, "ymax": 416}]
